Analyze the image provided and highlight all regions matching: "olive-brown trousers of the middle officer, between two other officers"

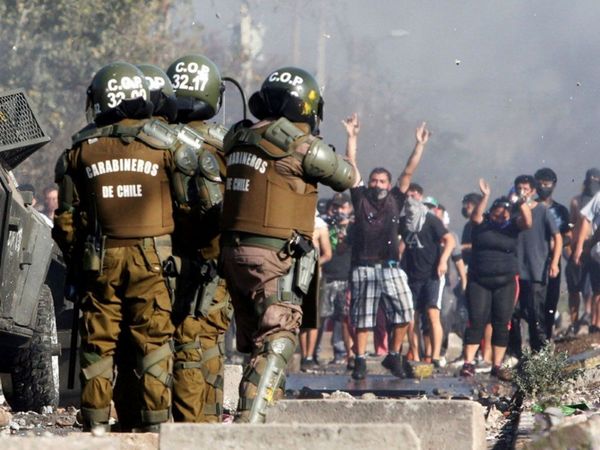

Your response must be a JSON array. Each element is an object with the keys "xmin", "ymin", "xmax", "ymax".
[{"xmin": 173, "ymin": 280, "xmax": 232, "ymax": 422}]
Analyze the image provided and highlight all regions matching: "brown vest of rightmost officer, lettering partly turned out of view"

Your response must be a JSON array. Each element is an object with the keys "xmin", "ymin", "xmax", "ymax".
[{"xmin": 221, "ymin": 124, "xmax": 318, "ymax": 239}]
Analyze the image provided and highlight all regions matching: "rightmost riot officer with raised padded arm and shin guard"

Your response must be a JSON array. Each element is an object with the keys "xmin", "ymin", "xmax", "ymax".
[{"xmin": 221, "ymin": 67, "xmax": 356, "ymax": 423}]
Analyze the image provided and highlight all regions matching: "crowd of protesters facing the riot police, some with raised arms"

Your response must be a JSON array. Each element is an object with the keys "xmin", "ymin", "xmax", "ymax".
[{"xmin": 308, "ymin": 114, "xmax": 600, "ymax": 380}]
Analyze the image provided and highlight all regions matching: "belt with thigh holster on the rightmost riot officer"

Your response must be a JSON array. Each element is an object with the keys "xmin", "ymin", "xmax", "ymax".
[{"xmin": 221, "ymin": 232, "xmax": 319, "ymax": 315}]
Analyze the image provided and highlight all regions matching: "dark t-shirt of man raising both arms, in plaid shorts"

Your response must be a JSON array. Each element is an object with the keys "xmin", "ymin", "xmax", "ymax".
[{"xmin": 350, "ymin": 186, "xmax": 406, "ymax": 265}]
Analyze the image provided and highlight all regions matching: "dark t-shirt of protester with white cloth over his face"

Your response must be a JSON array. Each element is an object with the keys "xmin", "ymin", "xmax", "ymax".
[{"xmin": 400, "ymin": 213, "xmax": 448, "ymax": 281}]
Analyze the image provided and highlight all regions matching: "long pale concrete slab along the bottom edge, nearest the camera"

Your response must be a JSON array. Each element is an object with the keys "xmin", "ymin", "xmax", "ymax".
[{"xmin": 160, "ymin": 423, "xmax": 428, "ymax": 450}]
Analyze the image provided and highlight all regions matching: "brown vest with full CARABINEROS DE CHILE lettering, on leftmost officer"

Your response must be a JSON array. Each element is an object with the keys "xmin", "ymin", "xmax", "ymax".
[{"xmin": 74, "ymin": 120, "xmax": 174, "ymax": 238}]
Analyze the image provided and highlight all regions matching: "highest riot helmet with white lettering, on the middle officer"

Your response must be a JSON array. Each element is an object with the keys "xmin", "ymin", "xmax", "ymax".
[{"xmin": 167, "ymin": 55, "xmax": 225, "ymax": 123}]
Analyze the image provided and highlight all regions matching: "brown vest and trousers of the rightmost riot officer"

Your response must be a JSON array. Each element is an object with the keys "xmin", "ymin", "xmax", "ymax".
[{"xmin": 221, "ymin": 122, "xmax": 317, "ymax": 422}]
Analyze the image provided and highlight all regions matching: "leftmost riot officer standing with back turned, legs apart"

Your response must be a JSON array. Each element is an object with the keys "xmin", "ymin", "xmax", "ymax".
[{"xmin": 53, "ymin": 62, "xmax": 175, "ymax": 431}]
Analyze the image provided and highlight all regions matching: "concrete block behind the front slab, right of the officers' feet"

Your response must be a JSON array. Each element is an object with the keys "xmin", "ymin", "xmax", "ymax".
[{"xmin": 267, "ymin": 400, "xmax": 486, "ymax": 450}]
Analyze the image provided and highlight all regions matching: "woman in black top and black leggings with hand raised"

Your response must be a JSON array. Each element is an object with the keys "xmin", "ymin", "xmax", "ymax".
[{"xmin": 461, "ymin": 179, "xmax": 531, "ymax": 378}]
